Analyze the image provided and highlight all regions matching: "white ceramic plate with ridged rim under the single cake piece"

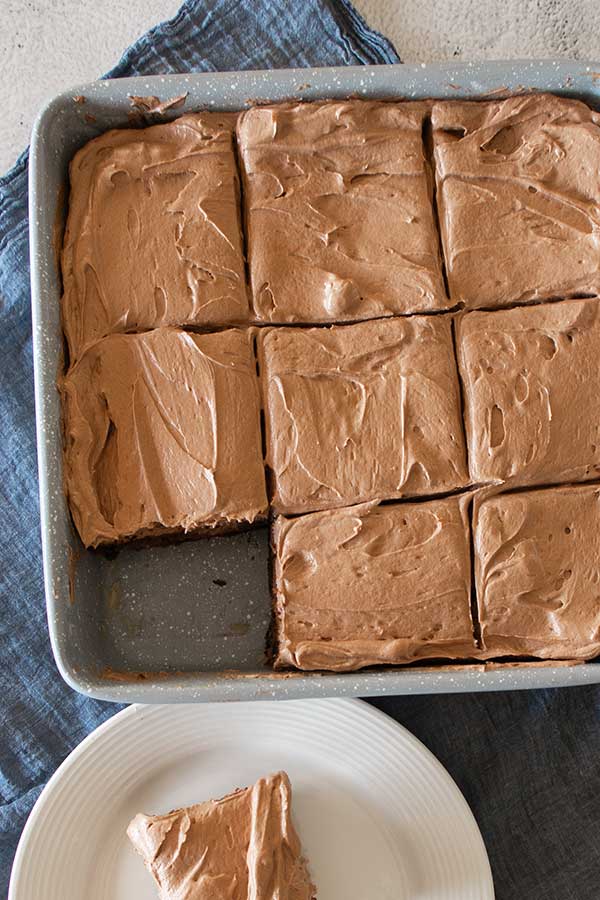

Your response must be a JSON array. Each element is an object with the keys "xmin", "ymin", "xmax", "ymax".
[{"xmin": 9, "ymin": 699, "xmax": 494, "ymax": 900}]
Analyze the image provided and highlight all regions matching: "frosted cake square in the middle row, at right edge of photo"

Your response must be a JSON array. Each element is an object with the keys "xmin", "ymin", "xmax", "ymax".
[{"xmin": 457, "ymin": 300, "xmax": 600, "ymax": 484}]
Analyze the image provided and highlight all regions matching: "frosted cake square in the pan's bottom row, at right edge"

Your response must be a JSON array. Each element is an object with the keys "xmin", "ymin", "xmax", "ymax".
[{"xmin": 474, "ymin": 485, "xmax": 600, "ymax": 659}]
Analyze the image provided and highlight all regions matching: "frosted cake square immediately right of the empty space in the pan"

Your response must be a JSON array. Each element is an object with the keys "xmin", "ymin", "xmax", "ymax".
[{"xmin": 273, "ymin": 495, "xmax": 476, "ymax": 671}]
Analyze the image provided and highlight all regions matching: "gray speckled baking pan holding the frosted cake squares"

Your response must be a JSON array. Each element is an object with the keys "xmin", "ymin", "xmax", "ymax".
[{"xmin": 29, "ymin": 60, "xmax": 600, "ymax": 703}]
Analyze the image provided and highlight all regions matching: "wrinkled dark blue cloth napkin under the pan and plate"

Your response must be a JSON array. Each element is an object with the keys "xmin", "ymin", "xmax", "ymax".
[{"xmin": 0, "ymin": 0, "xmax": 600, "ymax": 900}]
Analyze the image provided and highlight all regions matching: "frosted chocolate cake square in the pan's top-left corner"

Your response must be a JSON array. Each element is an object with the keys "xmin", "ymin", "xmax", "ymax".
[{"xmin": 62, "ymin": 113, "xmax": 249, "ymax": 360}]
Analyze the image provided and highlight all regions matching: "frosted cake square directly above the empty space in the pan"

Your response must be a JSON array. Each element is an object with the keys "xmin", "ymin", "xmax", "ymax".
[{"xmin": 61, "ymin": 328, "xmax": 267, "ymax": 547}]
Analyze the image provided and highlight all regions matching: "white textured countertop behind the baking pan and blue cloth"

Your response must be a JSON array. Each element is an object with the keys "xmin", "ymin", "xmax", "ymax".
[{"xmin": 0, "ymin": 0, "xmax": 600, "ymax": 172}]
